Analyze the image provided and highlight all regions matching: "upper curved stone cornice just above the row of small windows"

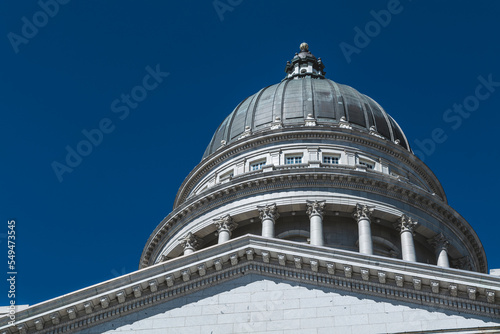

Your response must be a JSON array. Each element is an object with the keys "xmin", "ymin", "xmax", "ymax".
[{"xmin": 174, "ymin": 126, "xmax": 446, "ymax": 208}]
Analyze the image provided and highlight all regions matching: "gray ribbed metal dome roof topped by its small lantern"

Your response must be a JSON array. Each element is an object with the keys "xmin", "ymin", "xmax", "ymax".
[{"xmin": 203, "ymin": 46, "xmax": 410, "ymax": 158}]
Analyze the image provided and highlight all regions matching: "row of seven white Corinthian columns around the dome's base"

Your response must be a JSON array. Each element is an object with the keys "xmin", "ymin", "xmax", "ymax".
[{"xmin": 179, "ymin": 200, "xmax": 450, "ymax": 267}]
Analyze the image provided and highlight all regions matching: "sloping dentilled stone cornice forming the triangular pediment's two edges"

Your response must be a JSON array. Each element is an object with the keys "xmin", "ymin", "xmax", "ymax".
[{"xmin": 0, "ymin": 235, "xmax": 500, "ymax": 334}]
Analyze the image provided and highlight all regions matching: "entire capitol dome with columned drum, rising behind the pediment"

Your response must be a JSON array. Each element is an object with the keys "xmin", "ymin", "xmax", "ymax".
[{"xmin": 140, "ymin": 43, "xmax": 487, "ymax": 272}]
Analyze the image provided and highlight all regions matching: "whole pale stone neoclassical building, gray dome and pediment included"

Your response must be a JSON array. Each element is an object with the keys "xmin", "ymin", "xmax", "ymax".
[{"xmin": 0, "ymin": 43, "xmax": 500, "ymax": 334}]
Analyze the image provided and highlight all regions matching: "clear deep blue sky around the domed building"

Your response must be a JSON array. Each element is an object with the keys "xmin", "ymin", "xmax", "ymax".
[{"xmin": 0, "ymin": 0, "xmax": 500, "ymax": 304}]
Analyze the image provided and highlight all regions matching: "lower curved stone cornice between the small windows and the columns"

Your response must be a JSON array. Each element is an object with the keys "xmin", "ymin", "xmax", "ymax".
[{"xmin": 140, "ymin": 166, "xmax": 487, "ymax": 272}]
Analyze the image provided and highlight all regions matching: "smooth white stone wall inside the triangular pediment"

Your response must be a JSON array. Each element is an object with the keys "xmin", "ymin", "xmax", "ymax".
[{"xmin": 79, "ymin": 274, "xmax": 500, "ymax": 334}]
